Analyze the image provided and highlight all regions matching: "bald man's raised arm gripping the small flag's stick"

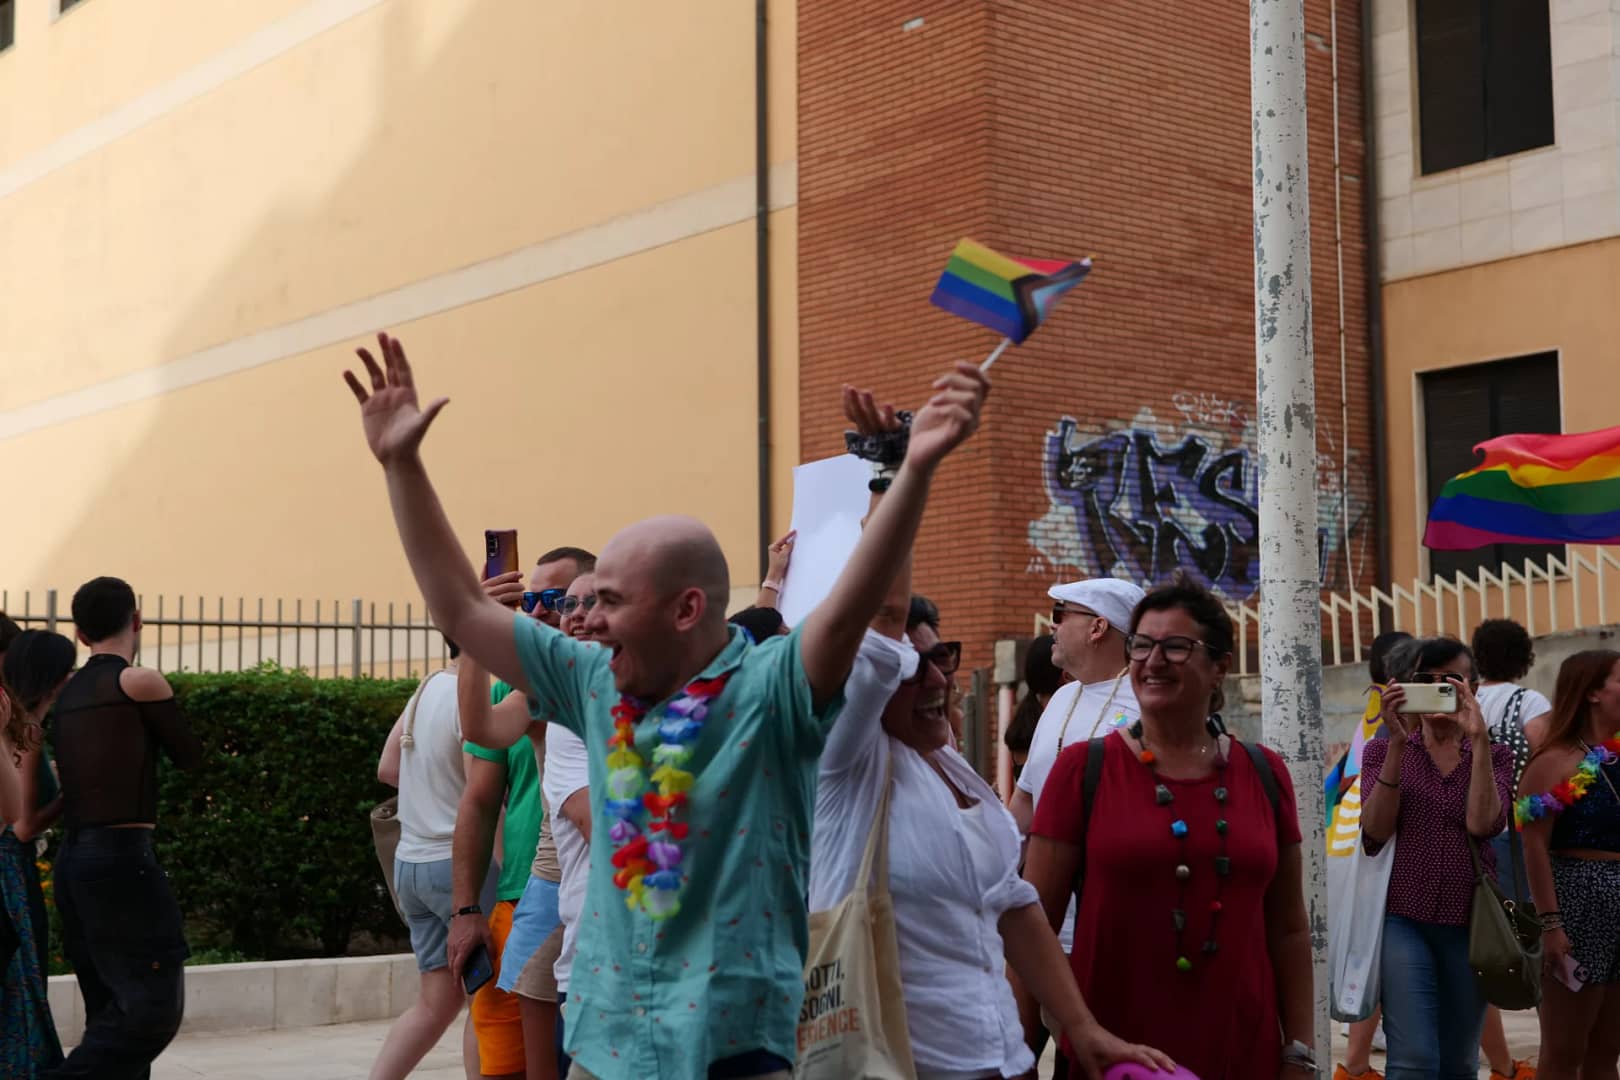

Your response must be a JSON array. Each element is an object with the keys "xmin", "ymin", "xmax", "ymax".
[{"xmin": 800, "ymin": 364, "xmax": 990, "ymax": 706}]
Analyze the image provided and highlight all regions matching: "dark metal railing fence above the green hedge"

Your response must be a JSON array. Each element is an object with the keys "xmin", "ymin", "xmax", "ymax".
[{"xmin": 0, "ymin": 589, "xmax": 449, "ymax": 678}]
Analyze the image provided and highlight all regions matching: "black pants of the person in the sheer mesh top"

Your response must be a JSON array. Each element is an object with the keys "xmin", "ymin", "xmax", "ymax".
[{"xmin": 44, "ymin": 829, "xmax": 186, "ymax": 1080}]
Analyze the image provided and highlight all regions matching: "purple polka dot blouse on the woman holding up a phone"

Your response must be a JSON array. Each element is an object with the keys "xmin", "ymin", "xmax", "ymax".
[{"xmin": 1361, "ymin": 730, "xmax": 1513, "ymax": 926}]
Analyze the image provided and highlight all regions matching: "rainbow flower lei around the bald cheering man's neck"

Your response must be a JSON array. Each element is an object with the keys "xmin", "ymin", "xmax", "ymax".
[{"xmin": 604, "ymin": 674, "xmax": 731, "ymax": 920}]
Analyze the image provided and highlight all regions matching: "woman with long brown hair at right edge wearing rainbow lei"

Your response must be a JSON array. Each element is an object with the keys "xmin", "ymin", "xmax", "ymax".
[{"xmin": 1513, "ymin": 649, "xmax": 1620, "ymax": 1080}]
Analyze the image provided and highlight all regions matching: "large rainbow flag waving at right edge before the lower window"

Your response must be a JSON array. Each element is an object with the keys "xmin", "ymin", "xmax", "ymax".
[{"xmin": 1422, "ymin": 427, "xmax": 1620, "ymax": 551}]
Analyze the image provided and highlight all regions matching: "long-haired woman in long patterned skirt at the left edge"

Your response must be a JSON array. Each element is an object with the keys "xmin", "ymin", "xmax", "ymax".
[{"xmin": 0, "ymin": 620, "xmax": 78, "ymax": 1077}]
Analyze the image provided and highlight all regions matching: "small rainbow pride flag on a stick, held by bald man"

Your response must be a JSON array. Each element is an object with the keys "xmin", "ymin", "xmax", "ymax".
[{"xmin": 932, "ymin": 240, "xmax": 1092, "ymax": 345}]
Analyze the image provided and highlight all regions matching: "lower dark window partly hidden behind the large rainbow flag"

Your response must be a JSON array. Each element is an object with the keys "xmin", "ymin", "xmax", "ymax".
[{"xmin": 1422, "ymin": 353, "xmax": 1563, "ymax": 578}]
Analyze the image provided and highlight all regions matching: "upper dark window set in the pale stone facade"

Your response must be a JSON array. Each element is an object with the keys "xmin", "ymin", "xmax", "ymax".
[{"xmin": 1418, "ymin": 0, "xmax": 1552, "ymax": 175}]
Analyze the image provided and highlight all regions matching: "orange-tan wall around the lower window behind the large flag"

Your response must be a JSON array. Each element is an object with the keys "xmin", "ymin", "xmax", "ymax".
[{"xmin": 1383, "ymin": 240, "xmax": 1620, "ymax": 592}]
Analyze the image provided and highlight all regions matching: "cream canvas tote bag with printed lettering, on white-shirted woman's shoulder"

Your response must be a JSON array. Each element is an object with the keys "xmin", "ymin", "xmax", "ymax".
[{"xmin": 794, "ymin": 751, "xmax": 917, "ymax": 1080}]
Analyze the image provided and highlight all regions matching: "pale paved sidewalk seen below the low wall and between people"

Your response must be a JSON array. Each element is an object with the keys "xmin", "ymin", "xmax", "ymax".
[{"xmin": 142, "ymin": 1012, "xmax": 1537, "ymax": 1080}]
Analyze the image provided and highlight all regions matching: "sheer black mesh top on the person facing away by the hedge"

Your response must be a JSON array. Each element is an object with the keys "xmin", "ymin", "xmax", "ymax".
[{"xmin": 50, "ymin": 654, "xmax": 203, "ymax": 831}]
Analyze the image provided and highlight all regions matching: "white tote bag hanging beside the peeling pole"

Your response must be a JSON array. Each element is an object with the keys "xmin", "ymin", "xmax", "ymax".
[{"xmin": 1327, "ymin": 836, "xmax": 1395, "ymax": 1022}]
